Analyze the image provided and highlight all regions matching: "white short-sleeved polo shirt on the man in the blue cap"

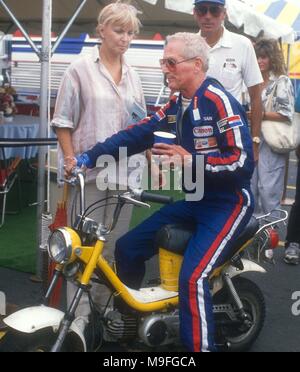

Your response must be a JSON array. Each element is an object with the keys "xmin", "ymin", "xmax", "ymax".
[{"xmin": 207, "ymin": 28, "xmax": 263, "ymax": 103}]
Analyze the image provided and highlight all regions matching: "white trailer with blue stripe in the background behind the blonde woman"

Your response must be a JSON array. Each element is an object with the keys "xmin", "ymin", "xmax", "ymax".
[{"xmin": 11, "ymin": 35, "xmax": 169, "ymax": 111}]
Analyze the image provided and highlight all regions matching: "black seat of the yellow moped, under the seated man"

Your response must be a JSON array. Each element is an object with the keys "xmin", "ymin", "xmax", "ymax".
[{"xmin": 156, "ymin": 217, "xmax": 259, "ymax": 255}]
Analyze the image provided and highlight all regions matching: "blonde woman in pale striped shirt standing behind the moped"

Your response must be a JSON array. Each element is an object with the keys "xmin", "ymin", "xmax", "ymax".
[{"xmin": 52, "ymin": 1, "xmax": 146, "ymax": 338}]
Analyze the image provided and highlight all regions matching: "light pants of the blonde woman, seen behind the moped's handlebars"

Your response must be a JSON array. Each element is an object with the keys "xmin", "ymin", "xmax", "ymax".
[{"xmin": 67, "ymin": 183, "xmax": 133, "ymax": 328}]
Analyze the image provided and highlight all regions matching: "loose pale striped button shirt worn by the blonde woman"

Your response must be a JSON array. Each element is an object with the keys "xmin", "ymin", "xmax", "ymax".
[{"xmin": 51, "ymin": 46, "xmax": 146, "ymax": 185}]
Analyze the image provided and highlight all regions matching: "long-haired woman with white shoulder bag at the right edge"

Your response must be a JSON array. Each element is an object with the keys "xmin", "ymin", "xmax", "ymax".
[{"xmin": 248, "ymin": 39, "xmax": 295, "ymax": 214}]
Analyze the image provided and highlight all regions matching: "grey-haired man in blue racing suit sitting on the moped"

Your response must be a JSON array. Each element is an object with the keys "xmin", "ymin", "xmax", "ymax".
[{"xmin": 77, "ymin": 33, "xmax": 254, "ymax": 351}]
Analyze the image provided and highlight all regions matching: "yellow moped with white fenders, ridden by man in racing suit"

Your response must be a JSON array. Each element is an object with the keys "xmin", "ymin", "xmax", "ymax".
[{"xmin": 0, "ymin": 169, "xmax": 288, "ymax": 352}]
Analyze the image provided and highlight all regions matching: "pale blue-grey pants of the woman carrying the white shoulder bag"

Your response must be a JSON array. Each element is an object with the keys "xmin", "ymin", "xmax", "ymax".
[{"xmin": 251, "ymin": 141, "xmax": 287, "ymax": 214}]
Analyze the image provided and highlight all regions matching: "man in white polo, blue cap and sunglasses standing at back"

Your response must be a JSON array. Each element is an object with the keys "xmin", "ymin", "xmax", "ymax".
[{"xmin": 194, "ymin": 0, "xmax": 263, "ymax": 161}]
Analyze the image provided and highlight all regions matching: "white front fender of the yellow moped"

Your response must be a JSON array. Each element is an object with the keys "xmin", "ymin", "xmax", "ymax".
[{"xmin": 3, "ymin": 306, "xmax": 86, "ymax": 351}]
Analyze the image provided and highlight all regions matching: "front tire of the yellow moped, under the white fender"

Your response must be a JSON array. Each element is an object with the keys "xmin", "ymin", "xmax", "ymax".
[{"xmin": 0, "ymin": 328, "xmax": 83, "ymax": 353}]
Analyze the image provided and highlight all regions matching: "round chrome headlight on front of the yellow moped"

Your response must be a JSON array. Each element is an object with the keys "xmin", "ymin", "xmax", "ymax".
[{"xmin": 48, "ymin": 229, "xmax": 72, "ymax": 264}]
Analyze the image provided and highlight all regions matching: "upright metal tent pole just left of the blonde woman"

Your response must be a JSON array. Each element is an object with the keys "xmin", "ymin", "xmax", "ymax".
[{"xmin": 36, "ymin": 0, "xmax": 52, "ymax": 279}]
